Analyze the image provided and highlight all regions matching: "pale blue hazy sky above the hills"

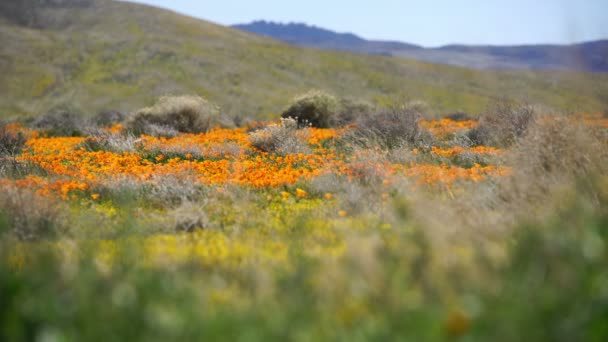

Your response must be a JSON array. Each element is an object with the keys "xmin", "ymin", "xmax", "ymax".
[{"xmin": 124, "ymin": 0, "xmax": 608, "ymax": 46}]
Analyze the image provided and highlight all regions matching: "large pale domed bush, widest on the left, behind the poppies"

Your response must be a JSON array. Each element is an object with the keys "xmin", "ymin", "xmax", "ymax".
[{"xmin": 125, "ymin": 95, "xmax": 220, "ymax": 136}]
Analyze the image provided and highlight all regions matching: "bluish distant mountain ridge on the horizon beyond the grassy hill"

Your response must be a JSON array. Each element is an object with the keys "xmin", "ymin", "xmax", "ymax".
[{"xmin": 233, "ymin": 21, "xmax": 608, "ymax": 72}]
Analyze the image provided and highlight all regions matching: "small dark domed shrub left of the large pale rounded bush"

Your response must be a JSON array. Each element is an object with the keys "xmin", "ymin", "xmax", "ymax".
[{"xmin": 33, "ymin": 105, "xmax": 85, "ymax": 137}]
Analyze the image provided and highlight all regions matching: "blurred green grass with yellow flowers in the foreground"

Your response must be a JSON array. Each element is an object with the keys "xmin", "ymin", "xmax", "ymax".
[{"xmin": 0, "ymin": 177, "xmax": 608, "ymax": 341}]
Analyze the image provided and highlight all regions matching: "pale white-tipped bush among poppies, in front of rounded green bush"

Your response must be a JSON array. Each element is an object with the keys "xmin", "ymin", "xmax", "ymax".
[{"xmin": 249, "ymin": 118, "xmax": 310, "ymax": 155}]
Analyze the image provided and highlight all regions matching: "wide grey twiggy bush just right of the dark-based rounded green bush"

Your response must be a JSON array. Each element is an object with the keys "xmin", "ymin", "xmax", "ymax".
[{"xmin": 351, "ymin": 103, "xmax": 432, "ymax": 149}]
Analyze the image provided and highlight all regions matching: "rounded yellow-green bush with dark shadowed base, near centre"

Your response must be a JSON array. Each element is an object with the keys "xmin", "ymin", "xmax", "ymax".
[{"xmin": 281, "ymin": 90, "xmax": 339, "ymax": 128}]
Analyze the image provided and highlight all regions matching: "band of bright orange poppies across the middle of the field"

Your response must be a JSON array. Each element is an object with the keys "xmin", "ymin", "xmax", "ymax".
[{"xmin": 9, "ymin": 119, "xmax": 508, "ymax": 199}]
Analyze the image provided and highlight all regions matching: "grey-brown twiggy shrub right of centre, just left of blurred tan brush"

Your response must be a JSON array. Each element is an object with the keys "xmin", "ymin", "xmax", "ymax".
[{"xmin": 469, "ymin": 100, "xmax": 535, "ymax": 147}]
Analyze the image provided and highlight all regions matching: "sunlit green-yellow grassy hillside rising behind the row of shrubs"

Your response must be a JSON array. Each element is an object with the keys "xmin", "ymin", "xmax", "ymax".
[{"xmin": 0, "ymin": 0, "xmax": 608, "ymax": 118}]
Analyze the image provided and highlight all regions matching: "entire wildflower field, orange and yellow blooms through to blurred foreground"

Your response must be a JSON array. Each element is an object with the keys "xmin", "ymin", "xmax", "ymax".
[{"xmin": 0, "ymin": 97, "xmax": 608, "ymax": 341}]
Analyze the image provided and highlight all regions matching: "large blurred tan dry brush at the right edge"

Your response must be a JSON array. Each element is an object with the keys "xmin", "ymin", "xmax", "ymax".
[{"xmin": 497, "ymin": 117, "xmax": 608, "ymax": 217}]
